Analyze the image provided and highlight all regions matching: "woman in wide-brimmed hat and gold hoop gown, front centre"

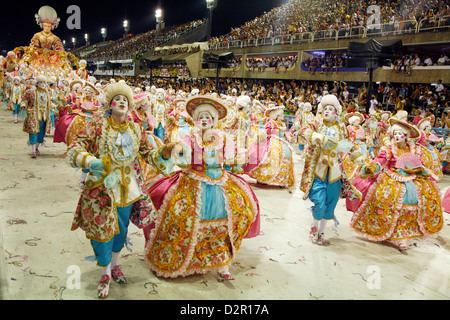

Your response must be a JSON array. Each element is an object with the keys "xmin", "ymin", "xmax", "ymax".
[{"xmin": 145, "ymin": 95, "xmax": 259, "ymax": 281}]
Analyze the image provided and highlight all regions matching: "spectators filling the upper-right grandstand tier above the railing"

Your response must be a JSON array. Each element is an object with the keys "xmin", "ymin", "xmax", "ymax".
[{"xmin": 210, "ymin": 0, "xmax": 450, "ymax": 47}]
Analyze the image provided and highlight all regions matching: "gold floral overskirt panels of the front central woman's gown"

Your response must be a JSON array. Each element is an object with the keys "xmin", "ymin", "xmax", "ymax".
[{"xmin": 146, "ymin": 173, "xmax": 256, "ymax": 277}]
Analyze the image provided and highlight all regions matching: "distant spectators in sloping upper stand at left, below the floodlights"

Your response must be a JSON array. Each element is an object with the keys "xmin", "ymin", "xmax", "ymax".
[{"xmin": 77, "ymin": 19, "xmax": 205, "ymax": 59}]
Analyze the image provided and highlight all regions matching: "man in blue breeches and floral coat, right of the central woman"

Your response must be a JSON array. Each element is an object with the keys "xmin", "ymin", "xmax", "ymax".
[{"xmin": 300, "ymin": 94, "xmax": 363, "ymax": 245}]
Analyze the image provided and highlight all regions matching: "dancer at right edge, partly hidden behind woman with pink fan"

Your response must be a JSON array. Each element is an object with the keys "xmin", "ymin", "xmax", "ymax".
[{"xmin": 417, "ymin": 118, "xmax": 444, "ymax": 181}]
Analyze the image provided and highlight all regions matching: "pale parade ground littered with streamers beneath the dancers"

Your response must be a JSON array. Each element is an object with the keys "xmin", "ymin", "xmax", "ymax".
[{"xmin": 0, "ymin": 105, "xmax": 450, "ymax": 301}]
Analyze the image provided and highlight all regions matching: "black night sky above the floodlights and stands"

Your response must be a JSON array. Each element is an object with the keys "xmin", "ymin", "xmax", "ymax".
[{"xmin": 0, "ymin": 0, "xmax": 287, "ymax": 55}]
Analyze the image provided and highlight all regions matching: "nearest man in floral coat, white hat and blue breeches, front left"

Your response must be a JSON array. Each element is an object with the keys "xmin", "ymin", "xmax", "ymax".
[{"xmin": 68, "ymin": 83, "xmax": 179, "ymax": 298}]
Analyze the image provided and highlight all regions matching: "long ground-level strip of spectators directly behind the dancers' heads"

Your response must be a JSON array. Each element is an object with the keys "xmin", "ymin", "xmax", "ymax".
[{"xmin": 94, "ymin": 77, "xmax": 450, "ymax": 129}]
